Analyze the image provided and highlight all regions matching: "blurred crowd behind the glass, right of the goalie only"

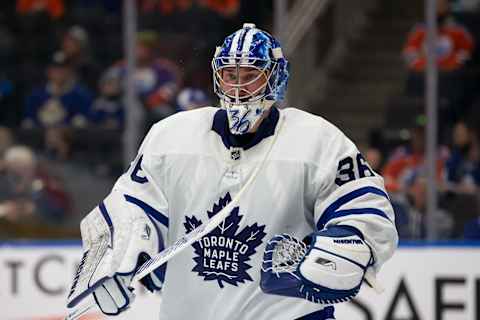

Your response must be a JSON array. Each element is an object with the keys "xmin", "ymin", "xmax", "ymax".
[{"xmin": 366, "ymin": 0, "xmax": 480, "ymax": 240}]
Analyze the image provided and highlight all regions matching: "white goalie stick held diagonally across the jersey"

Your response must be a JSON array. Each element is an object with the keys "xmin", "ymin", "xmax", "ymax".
[{"xmin": 65, "ymin": 116, "xmax": 284, "ymax": 320}]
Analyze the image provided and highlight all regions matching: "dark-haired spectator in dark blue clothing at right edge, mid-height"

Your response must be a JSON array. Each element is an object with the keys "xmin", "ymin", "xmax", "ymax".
[{"xmin": 446, "ymin": 121, "xmax": 480, "ymax": 194}]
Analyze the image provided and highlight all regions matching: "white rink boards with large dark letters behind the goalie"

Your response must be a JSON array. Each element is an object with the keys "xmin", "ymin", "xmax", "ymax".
[{"xmin": 0, "ymin": 241, "xmax": 480, "ymax": 320}]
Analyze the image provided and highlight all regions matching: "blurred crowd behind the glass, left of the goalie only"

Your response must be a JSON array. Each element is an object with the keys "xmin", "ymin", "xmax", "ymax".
[{"xmin": 0, "ymin": 0, "xmax": 272, "ymax": 239}]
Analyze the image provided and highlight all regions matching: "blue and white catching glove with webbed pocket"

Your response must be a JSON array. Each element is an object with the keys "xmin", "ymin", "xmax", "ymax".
[{"xmin": 260, "ymin": 226, "xmax": 373, "ymax": 304}]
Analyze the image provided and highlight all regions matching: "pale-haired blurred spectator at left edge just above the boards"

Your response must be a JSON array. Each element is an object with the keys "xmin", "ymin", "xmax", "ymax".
[{"xmin": 0, "ymin": 145, "xmax": 70, "ymax": 224}]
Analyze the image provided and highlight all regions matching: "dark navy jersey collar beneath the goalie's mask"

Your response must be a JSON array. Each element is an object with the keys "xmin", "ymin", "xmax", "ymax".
[{"xmin": 212, "ymin": 106, "xmax": 280, "ymax": 150}]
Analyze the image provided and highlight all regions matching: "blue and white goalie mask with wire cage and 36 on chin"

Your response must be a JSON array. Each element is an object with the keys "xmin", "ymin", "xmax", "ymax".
[{"xmin": 212, "ymin": 23, "xmax": 288, "ymax": 135}]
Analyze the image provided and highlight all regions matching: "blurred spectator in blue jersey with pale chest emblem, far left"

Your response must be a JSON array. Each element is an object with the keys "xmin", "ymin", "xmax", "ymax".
[{"xmin": 22, "ymin": 51, "xmax": 92, "ymax": 128}]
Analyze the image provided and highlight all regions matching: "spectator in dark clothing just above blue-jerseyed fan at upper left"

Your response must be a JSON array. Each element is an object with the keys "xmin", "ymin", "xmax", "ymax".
[{"xmin": 61, "ymin": 26, "xmax": 100, "ymax": 89}]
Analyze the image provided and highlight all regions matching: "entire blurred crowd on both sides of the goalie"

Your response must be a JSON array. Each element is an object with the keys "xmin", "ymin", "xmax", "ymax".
[{"xmin": 0, "ymin": 0, "xmax": 480, "ymax": 239}]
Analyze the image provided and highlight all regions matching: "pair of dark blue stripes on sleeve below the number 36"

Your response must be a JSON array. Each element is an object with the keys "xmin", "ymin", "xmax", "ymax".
[{"xmin": 317, "ymin": 187, "xmax": 390, "ymax": 230}]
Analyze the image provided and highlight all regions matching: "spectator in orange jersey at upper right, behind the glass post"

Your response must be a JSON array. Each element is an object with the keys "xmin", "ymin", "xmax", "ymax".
[{"xmin": 403, "ymin": 1, "xmax": 474, "ymax": 72}]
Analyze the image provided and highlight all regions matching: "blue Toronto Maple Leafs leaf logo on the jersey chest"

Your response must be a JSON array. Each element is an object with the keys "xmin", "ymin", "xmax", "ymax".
[{"xmin": 183, "ymin": 193, "xmax": 266, "ymax": 288}]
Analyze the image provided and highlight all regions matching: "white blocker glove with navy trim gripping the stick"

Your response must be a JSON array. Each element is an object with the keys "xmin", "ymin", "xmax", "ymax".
[{"xmin": 67, "ymin": 192, "xmax": 165, "ymax": 315}]
